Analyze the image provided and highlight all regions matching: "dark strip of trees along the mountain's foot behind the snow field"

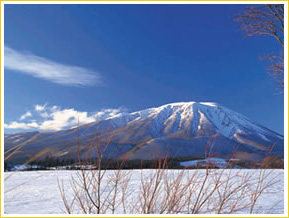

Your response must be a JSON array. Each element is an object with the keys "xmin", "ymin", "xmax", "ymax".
[{"xmin": 4, "ymin": 155, "xmax": 284, "ymax": 171}]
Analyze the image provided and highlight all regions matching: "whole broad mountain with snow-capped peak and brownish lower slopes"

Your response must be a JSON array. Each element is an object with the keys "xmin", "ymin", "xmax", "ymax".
[{"xmin": 5, "ymin": 102, "xmax": 284, "ymax": 164}]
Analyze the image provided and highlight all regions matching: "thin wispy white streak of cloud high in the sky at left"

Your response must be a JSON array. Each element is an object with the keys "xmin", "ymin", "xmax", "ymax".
[{"xmin": 4, "ymin": 46, "xmax": 102, "ymax": 86}]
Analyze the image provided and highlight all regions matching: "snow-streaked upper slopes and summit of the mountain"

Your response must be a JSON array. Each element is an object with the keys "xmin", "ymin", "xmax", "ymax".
[{"xmin": 108, "ymin": 102, "xmax": 283, "ymax": 141}]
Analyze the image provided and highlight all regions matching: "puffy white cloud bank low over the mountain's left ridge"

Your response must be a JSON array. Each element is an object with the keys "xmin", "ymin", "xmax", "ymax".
[{"xmin": 4, "ymin": 104, "xmax": 126, "ymax": 131}]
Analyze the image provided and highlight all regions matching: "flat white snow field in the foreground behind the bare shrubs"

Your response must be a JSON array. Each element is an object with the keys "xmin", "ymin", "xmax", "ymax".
[{"xmin": 4, "ymin": 169, "xmax": 284, "ymax": 214}]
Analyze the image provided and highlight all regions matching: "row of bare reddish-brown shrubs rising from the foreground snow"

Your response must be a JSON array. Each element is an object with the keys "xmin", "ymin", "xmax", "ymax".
[{"xmin": 59, "ymin": 132, "xmax": 278, "ymax": 214}]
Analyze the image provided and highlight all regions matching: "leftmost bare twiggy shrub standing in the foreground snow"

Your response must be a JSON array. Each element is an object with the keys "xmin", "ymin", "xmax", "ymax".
[{"xmin": 59, "ymin": 126, "xmax": 131, "ymax": 214}]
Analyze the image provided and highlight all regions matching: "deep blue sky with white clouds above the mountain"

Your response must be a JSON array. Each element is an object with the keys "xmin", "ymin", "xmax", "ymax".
[{"xmin": 4, "ymin": 5, "xmax": 284, "ymax": 134}]
